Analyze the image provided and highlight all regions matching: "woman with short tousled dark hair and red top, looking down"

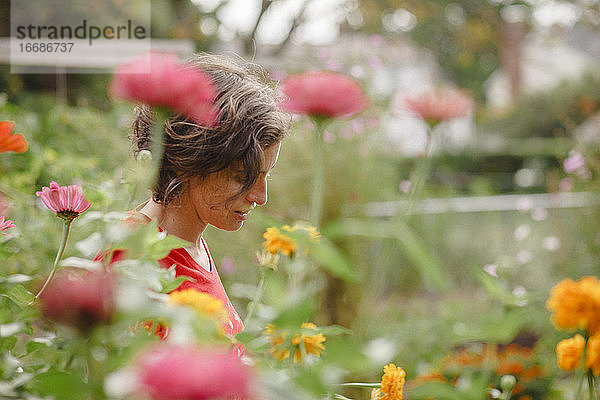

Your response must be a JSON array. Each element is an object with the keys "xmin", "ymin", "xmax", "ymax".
[{"xmin": 131, "ymin": 54, "xmax": 290, "ymax": 336}]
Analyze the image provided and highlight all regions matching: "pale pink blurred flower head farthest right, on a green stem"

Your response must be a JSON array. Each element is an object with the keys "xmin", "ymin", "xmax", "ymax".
[{"xmin": 404, "ymin": 89, "xmax": 473, "ymax": 127}]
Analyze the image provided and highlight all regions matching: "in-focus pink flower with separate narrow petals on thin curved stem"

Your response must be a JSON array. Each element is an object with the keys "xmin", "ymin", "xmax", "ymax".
[{"xmin": 35, "ymin": 181, "xmax": 91, "ymax": 221}]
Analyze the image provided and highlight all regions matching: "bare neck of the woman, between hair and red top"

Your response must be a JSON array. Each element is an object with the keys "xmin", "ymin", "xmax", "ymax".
[{"xmin": 139, "ymin": 199, "xmax": 206, "ymax": 243}]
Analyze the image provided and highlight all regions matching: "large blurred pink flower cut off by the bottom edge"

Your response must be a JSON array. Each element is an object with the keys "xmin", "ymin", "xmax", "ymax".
[{"xmin": 138, "ymin": 344, "xmax": 251, "ymax": 400}]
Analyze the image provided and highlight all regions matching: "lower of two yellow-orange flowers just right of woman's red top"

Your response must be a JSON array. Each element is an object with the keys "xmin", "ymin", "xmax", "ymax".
[{"xmin": 263, "ymin": 322, "xmax": 326, "ymax": 363}]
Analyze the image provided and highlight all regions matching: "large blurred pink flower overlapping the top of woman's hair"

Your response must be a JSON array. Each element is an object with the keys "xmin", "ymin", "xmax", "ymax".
[{"xmin": 109, "ymin": 53, "xmax": 217, "ymax": 127}]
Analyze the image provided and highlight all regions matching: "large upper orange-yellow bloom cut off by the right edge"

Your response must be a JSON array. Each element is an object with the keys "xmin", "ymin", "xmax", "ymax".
[{"xmin": 546, "ymin": 276, "xmax": 600, "ymax": 334}]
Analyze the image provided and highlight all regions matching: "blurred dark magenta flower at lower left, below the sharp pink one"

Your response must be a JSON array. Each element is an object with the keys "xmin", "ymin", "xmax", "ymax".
[{"xmin": 40, "ymin": 268, "xmax": 115, "ymax": 332}]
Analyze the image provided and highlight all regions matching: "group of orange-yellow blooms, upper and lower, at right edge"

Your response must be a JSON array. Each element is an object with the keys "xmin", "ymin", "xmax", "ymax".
[{"xmin": 546, "ymin": 276, "xmax": 600, "ymax": 376}]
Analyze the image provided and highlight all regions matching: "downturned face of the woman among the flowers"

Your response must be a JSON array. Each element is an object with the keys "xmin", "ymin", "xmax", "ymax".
[{"xmin": 184, "ymin": 143, "xmax": 281, "ymax": 231}]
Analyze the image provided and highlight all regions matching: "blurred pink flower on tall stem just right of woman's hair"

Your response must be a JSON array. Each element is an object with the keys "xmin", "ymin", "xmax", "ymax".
[{"xmin": 282, "ymin": 72, "xmax": 368, "ymax": 118}]
